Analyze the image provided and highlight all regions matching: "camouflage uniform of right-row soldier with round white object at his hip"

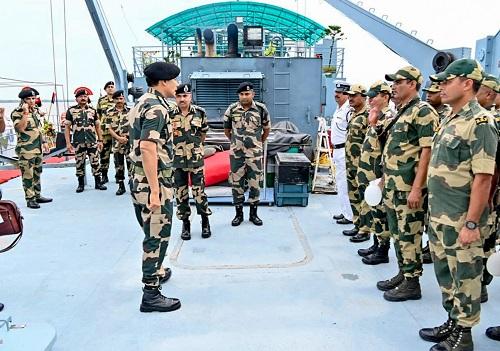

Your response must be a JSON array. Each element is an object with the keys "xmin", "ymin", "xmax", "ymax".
[{"xmin": 357, "ymin": 107, "xmax": 394, "ymax": 244}]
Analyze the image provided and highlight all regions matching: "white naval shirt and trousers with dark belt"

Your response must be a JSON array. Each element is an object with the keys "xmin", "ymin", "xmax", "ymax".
[{"xmin": 331, "ymin": 100, "xmax": 352, "ymax": 221}]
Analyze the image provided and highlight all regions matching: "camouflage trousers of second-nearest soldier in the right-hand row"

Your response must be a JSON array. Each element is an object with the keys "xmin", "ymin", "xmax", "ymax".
[{"xmin": 385, "ymin": 189, "xmax": 427, "ymax": 278}]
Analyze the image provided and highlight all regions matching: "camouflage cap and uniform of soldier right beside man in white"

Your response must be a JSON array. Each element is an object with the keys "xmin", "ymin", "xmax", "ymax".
[{"xmin": 345, "ymin": 91, "xmax": 371, "ymax": 233}]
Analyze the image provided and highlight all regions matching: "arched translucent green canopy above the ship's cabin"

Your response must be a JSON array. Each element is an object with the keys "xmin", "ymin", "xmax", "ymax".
[{"xmin": 146, "ymin": 1, "xmax": 325, "ymax": 46}]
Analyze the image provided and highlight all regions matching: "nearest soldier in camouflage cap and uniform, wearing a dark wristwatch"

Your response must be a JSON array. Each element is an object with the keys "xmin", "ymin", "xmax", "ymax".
[{"xmin": 419, "ymin": 59, "xmax": 498, "ymax": 351}]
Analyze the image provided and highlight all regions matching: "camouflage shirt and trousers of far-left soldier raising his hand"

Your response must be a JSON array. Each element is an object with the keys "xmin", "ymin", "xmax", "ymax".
[{"xmin": 10, "ymin": 108, "xmax": 43, "ymax": 201}]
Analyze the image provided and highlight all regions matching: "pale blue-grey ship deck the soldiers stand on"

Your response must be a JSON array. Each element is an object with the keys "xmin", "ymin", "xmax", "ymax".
[{"xmin": 0, "ymin": 168, "xmax": 500, "ymax": 351}]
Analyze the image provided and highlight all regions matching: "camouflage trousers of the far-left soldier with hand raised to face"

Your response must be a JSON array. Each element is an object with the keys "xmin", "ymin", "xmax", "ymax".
[{"xmin": 17, "ymin": 153, "xmax": 42, "ymax": 201}]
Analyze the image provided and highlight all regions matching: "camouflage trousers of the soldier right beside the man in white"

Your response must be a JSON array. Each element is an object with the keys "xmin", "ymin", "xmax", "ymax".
[{"xmin": 347, "ymin": 167, "xmax": 372, "ymax": 233}]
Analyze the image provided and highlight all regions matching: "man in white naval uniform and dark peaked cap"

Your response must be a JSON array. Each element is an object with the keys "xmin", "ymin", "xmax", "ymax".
[{"xmin": 331, "ymin": 82, "xmax": 353, "ymax": 224}]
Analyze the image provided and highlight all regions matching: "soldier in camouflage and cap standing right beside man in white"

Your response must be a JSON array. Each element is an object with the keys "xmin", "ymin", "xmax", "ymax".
[{"xmin": 342, "ymin": 84, "xmax": 371, "ymax": 242}]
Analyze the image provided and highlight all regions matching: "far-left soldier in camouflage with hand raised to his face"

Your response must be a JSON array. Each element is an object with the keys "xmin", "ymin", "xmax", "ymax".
[{"xmin": 11, "ymin": 88, "xmax": 52, "ymax": 208}]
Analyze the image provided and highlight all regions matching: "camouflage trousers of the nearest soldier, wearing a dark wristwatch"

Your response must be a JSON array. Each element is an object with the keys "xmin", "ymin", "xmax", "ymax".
[{"xmin": 428, "ymin": 220, "xmax": 488, "ymax": 327}]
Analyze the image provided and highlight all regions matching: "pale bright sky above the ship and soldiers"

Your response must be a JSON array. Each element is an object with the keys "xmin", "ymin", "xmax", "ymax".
[{"xmin": 0, "ymin": 0, "xmax": 500, "ymax": 108}]
